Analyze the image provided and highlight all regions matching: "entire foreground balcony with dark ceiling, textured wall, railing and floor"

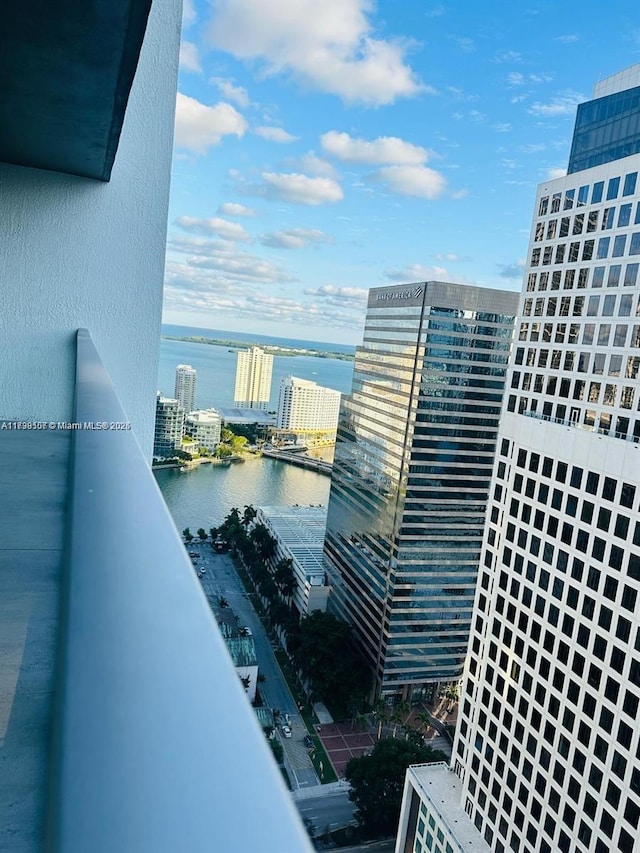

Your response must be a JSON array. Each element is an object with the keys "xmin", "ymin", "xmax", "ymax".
[{"xmin": 0, "ymin": 0, "xmax": 311, "ymax": 853}]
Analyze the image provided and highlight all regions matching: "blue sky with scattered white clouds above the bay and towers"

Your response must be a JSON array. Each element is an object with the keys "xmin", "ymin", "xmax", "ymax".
[{"xmin": 164, "ymin": 0, "xmax": 640, "ymax": 343}]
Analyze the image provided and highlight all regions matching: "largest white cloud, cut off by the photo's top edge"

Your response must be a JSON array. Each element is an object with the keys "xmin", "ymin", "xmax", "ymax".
[{"xmin": 208, "ymin": 0, "xmax": 427, "ymax": 106}]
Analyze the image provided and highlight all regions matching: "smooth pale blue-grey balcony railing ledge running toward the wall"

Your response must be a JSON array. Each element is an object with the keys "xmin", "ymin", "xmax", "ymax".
[{"xmin": 47, "ymin": 330, "xmax": 311, "ymax": 853}]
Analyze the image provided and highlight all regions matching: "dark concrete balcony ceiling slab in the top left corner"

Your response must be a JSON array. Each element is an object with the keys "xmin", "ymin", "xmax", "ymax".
[{"xmin": 0, "ymin": 0, "xmax": 151, "ymax": 181}]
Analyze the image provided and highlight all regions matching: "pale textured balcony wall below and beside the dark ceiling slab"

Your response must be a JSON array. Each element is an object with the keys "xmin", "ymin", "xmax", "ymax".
[{"xmin": 0, "ymin": 0, "xmax": 182, "ymax": 459}]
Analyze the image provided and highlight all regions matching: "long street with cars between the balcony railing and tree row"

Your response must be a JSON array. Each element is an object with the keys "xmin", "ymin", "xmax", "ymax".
[{"xmin": 189, "ymin": 543, "xmax": 320, "ymax": 790}]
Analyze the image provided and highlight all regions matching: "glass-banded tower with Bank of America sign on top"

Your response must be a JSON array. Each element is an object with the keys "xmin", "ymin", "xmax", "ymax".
[{"xmin": 325, "ymin": 282, "xmax": 518, "ymax": 696}]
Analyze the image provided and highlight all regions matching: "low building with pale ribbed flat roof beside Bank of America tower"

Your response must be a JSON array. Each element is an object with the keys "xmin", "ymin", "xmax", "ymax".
[{"xmin": 256, "ymin": 506, "xmax": 329, "ymax": 616}]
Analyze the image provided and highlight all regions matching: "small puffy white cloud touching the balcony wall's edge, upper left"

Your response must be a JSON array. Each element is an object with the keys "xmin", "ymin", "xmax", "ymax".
[{"xmin": 175, "ymin": 92, "xmax": 248, "ymax": 154}]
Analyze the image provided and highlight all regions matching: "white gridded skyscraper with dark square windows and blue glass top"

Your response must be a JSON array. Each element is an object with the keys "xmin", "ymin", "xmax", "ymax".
[{"xmin": 397, "ymin": 65, "xmax": 640, "ymax": 853}]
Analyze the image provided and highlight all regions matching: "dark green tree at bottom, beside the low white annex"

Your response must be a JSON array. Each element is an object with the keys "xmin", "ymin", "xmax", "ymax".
[{"xmin": 345, "ymin": 738, "xmax": 446, "ymax": 838}]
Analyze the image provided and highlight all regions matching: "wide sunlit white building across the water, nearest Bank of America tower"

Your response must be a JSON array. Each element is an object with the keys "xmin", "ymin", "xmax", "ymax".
[{"xmin": 277, "ymin": 376, "xmax": 341, "ymax": 438}]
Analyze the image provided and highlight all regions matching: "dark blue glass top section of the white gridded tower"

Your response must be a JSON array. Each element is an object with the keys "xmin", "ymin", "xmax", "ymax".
[{"xmin": 568, "ymin": 86, "xmax": 640, "ymax": 174}]
